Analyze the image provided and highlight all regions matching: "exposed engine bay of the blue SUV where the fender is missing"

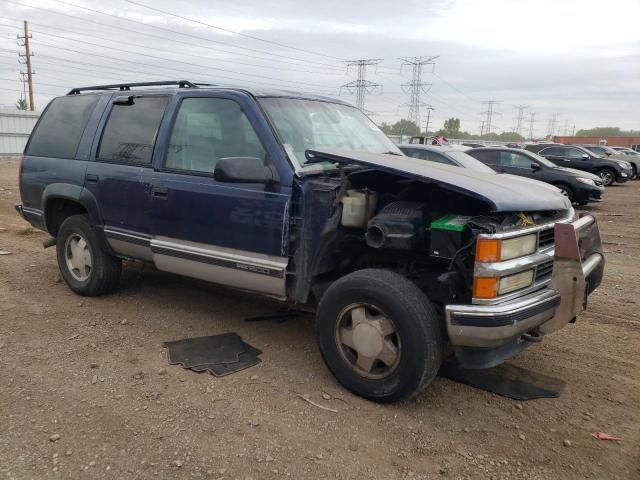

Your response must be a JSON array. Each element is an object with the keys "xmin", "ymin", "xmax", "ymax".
[{"xmin": 291, "ymin": 167, "xmax": 567, "ymax": 305}]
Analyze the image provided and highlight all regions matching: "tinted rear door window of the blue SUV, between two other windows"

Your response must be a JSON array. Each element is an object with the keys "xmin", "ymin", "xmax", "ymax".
[{"xmin": 98, "ymin": 96, "xmax": 169, "ymax": 164}]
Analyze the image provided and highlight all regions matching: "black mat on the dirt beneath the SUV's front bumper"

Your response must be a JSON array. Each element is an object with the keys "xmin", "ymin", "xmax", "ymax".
[{"xmin": 438, "ymin": 360, "xmax": 565, "ymax": 400}]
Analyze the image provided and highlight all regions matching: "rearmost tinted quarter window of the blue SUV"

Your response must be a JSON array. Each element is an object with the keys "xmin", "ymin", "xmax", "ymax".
[{"xmin": 25, "ymin": 95, "xmax": 98, "ymax": 158}]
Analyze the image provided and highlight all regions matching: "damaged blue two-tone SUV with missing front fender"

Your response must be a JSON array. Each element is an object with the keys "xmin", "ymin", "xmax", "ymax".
[{"xmin": 16, "ymin": 81, "xmax": 604, "ymax": 401}]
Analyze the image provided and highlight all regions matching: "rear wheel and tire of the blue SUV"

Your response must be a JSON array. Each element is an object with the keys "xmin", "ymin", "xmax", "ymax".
[{"xmin": 56, "ymin": 215, "xmax": 122, "ymax": 297}]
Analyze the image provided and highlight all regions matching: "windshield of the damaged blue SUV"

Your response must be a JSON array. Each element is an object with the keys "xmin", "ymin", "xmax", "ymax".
[{"xmin": 260, "ymin": 97, "xmax": 404, "ymax": 167}]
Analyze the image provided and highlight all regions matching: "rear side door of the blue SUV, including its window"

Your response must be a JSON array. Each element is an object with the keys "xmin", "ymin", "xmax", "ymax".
[{"xmin": 85, "ymin": 95, "xmax": 170, "ymax": 260}]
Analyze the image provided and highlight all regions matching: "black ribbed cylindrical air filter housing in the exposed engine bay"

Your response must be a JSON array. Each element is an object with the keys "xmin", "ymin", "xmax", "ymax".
[{"xmin": 365, "ymin": 202, "xmax": 425, "ymax": 250}]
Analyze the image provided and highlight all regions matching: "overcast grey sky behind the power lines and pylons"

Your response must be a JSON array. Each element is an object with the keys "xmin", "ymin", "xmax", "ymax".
[{"xmin": 0, "ymin": 0, "xmax": 640, "ymax": 136}]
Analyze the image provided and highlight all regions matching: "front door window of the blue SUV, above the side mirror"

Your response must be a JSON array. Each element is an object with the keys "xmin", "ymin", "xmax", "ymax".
[{"xmin": 165, "ymin": 98, "xmax": 266, "ymax": 173}]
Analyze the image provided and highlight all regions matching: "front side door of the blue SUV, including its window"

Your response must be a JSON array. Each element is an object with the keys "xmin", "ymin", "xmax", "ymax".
[{"xmin": 149, "ymin": 94, "xmax": 290, "ymax": 297}]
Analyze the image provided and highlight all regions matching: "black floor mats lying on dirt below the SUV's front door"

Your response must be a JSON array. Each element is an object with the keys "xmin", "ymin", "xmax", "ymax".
[{"xmin": 164, "ymin": 333, "xmax": 262, "ymax": 377}]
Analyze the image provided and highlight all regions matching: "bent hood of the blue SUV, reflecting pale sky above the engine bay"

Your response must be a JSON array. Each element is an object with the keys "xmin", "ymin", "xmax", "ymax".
[{"xmin": 307, "ymin": 150, "xmax": 571, "ymax": 212}]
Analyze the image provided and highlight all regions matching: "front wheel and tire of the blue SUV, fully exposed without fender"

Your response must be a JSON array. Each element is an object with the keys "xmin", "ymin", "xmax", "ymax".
[{"xmin": 316, "ymin": 269, "xmax": 444, "ymax": 402}]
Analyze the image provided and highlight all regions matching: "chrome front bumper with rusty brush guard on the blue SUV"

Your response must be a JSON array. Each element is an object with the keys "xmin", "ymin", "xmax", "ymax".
[{"xmin": 445, "ymin": 215, "xmax": 604, "ymax": 348}]
